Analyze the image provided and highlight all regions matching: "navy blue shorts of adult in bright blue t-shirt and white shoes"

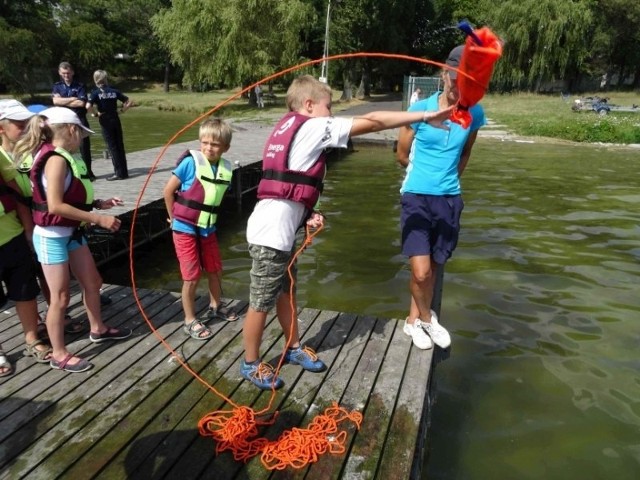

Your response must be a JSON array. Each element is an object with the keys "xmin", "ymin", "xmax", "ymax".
[{"xmin": 400, "ymin": 193, "xmax": 464, "ymax": 265}]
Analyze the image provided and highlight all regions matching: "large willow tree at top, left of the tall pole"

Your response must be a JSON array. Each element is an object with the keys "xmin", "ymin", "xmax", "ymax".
[{"xmin": 151, "ymin": 0, "xmax": 313, "ymax": 86}]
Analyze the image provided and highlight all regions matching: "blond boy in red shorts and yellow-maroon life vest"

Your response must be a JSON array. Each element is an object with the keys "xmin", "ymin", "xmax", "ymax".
[{"xmin": 164, "ymin": 118, "xmax": 238, "ymax": 340}]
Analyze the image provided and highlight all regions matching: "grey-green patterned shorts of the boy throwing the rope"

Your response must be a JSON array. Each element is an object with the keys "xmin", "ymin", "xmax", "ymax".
[{"xmin": 249, "ymin": 244, "xmax": 298, "ymax": 312}]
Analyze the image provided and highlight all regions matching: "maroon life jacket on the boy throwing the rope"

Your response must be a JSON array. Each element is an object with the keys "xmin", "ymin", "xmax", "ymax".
[{"xmin": 258, "ymin": 112, "xmax": 327, "ymax": 210}]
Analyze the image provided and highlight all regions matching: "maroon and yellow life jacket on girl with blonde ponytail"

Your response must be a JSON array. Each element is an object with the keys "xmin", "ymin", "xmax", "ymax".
[{"xmin": 31, "ymin": 143, "xmax": 93, "ymax": 227}]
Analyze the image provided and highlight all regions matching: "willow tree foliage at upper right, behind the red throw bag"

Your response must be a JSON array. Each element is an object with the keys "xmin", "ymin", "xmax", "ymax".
[{"xmin": 491, "ymin": 0, "xmax": 593, "ymax": 91}]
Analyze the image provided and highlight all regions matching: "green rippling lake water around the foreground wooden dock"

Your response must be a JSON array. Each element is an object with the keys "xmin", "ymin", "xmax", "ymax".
[{"xmin": 104, "ymin": 139, "xmax": 640, "ymax": 480}]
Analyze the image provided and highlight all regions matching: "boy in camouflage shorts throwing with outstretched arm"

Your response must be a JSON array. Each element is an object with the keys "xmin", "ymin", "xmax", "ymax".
[{"xmin": 240, "ymin": 75, "xmax": 452, "ymax": 390}]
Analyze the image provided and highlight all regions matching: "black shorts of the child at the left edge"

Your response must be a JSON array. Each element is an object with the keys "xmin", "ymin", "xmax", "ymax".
[{"xmin": 0, "ymin": 233, "xmax": 40, "ymax": 307}]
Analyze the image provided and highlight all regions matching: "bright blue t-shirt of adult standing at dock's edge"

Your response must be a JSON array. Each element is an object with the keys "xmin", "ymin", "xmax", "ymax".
[{"xmin": 400, "ymin": 92, "xmax": 487, "ymax": 195}]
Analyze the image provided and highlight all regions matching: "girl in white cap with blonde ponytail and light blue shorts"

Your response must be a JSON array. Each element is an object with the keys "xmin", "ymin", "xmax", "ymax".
[{"xmin": 15, "ymin": 107, "xmax": 131, "ymax": 372}]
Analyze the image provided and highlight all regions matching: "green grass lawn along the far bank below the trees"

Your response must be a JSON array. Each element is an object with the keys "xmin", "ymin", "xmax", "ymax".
[{"xmin": 6, "ymin": 82, "xmax": 640, "ymax": 144}]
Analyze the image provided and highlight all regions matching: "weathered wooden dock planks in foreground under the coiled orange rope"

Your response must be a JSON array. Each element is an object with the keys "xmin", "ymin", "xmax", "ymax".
[{"xmin": 0, "ymin": 285, "xmax": 432, "ymax": 480}]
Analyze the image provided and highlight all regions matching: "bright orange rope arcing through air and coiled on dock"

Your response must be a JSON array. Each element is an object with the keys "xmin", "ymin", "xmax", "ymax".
[{"xmin": 129, "ymin": 52, "xmax": 456, "ymax": 470}]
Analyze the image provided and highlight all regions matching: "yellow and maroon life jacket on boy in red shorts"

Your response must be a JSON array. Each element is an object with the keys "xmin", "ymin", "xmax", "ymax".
[{"xmin": 171, "ymin": 150, "xmax": 233, "ymax": 228}]
